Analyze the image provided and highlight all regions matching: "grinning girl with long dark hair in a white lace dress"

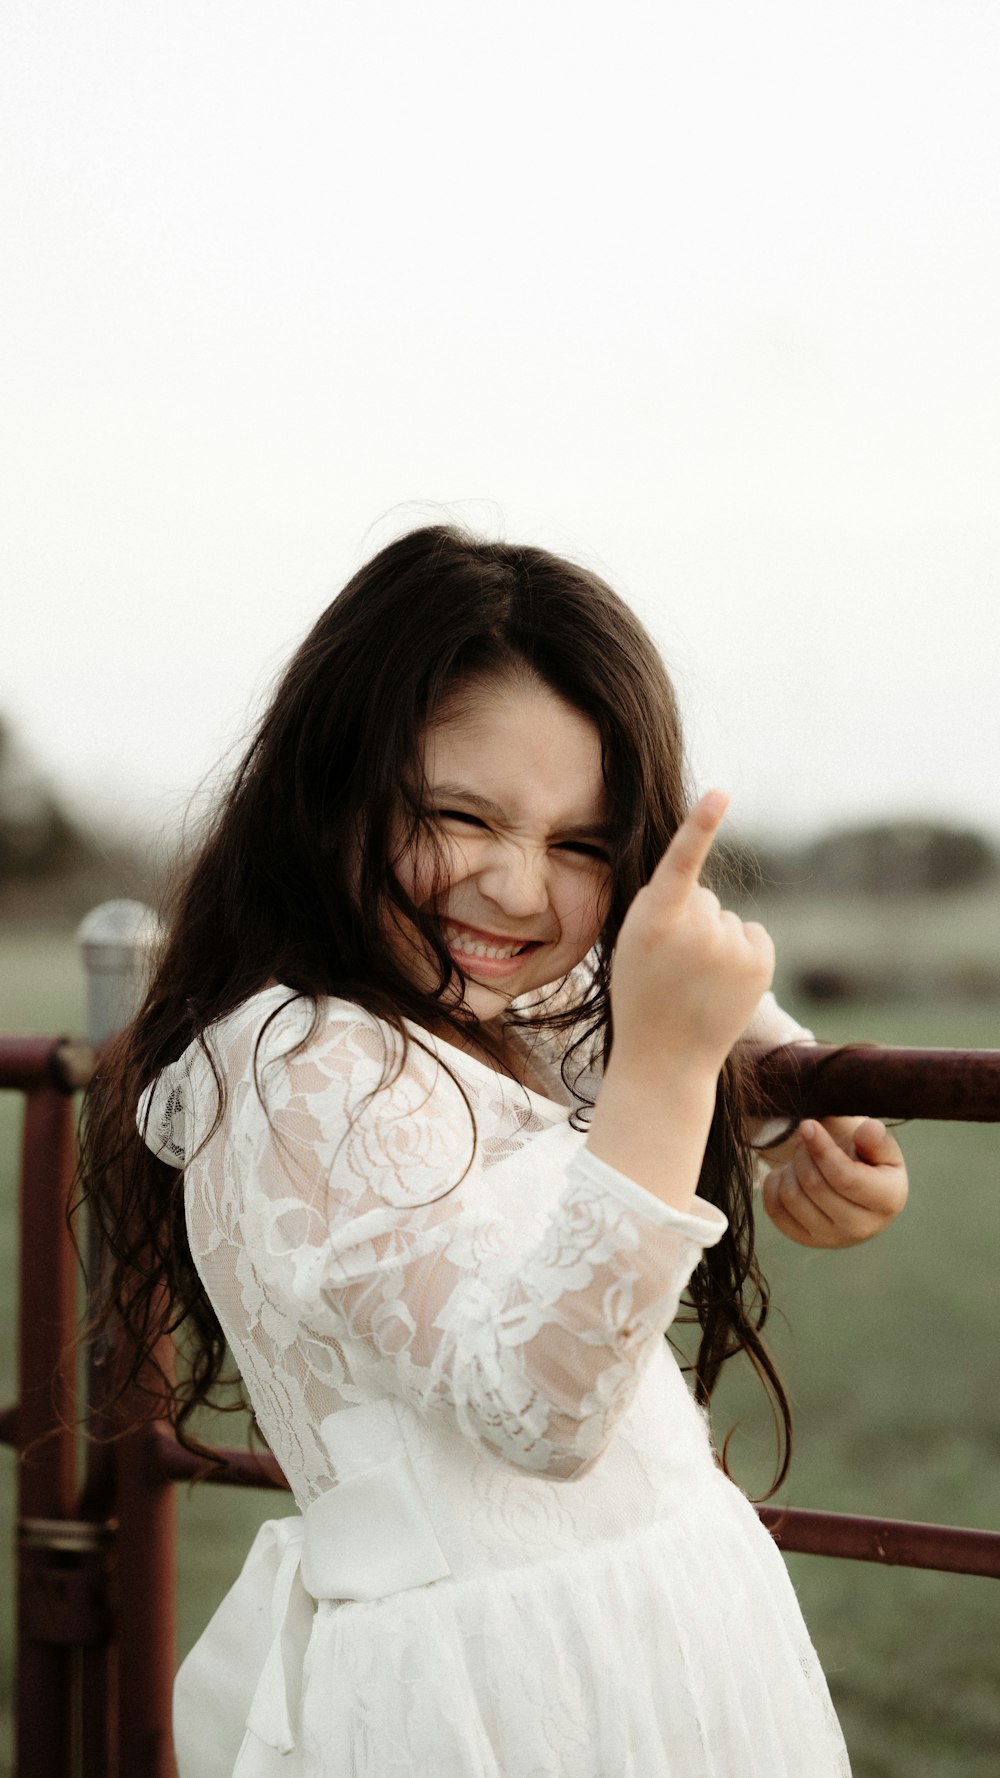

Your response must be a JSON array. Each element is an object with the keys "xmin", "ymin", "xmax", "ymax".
[{"xmin": 84, "ymin": 526, "xmax": 906, "ymax": 1778}]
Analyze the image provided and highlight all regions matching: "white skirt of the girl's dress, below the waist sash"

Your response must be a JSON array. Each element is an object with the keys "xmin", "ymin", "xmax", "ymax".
[{"xmin": 174, "ymin": 1474, "xmax": 851, "ymax": 1778}]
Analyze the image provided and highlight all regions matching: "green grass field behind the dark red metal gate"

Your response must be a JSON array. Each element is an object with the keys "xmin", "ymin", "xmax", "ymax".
[{"xmin": 0, "ymin": 910, "xmax": 1000, "ymax": 1778}]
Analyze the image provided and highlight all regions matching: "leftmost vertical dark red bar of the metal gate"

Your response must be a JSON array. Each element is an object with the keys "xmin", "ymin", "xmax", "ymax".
[{"xmin": 16, "ymin": 1085, "xmax": 77, "ymax": 1778}]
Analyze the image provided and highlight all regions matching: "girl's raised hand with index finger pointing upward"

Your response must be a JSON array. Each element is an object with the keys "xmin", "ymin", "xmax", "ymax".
[{"xmin": 610, "ymin": 791, "xmax": 774, "ymax": 1074}]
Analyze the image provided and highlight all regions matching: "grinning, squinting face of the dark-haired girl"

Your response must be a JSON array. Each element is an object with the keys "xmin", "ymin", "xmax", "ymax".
[{"xmin": 387, "ymin": 681, "xmax": 610, "ymax": 1021}]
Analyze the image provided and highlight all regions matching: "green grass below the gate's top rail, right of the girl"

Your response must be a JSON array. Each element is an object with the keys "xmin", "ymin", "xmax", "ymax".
[{"xmin": 714, "ymin": 1102, "xmax": 1000, "ymax": 1778}]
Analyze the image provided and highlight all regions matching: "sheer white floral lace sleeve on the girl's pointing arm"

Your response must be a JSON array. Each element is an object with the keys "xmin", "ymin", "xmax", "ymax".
[{"xmin": 226, "ymin": 1008, "xmax": 726, "ymax": 1479}]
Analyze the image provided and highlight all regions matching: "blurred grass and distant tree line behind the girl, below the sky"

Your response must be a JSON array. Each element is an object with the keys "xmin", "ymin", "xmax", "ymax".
[{"xmin": 0, "ymin": 714, "xmax": 1000, "ymax": 1778}]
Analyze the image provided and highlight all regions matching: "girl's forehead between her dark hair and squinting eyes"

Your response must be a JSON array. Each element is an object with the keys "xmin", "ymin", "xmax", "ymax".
[{"xmin": 422, "ymin": 681, "xmax": 609, "ymax": 827}]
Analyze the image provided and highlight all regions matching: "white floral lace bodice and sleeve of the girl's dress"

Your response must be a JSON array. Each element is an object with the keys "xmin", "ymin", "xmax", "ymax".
[{"xmin": 142, "ymin": 990, "xmax": 724, "ymax": 1504}]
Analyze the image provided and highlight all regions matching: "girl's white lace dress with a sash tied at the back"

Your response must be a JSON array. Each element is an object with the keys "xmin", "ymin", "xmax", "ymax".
[{"xmin": 141, "ymin": 989, "xmax": 849, "ymax": 1778}]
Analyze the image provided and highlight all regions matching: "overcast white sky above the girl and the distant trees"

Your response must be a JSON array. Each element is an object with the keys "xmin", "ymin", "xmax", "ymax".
[{"xmin": 0, "ymin": 0, "xmax": 1000, "ymax": 846}]
